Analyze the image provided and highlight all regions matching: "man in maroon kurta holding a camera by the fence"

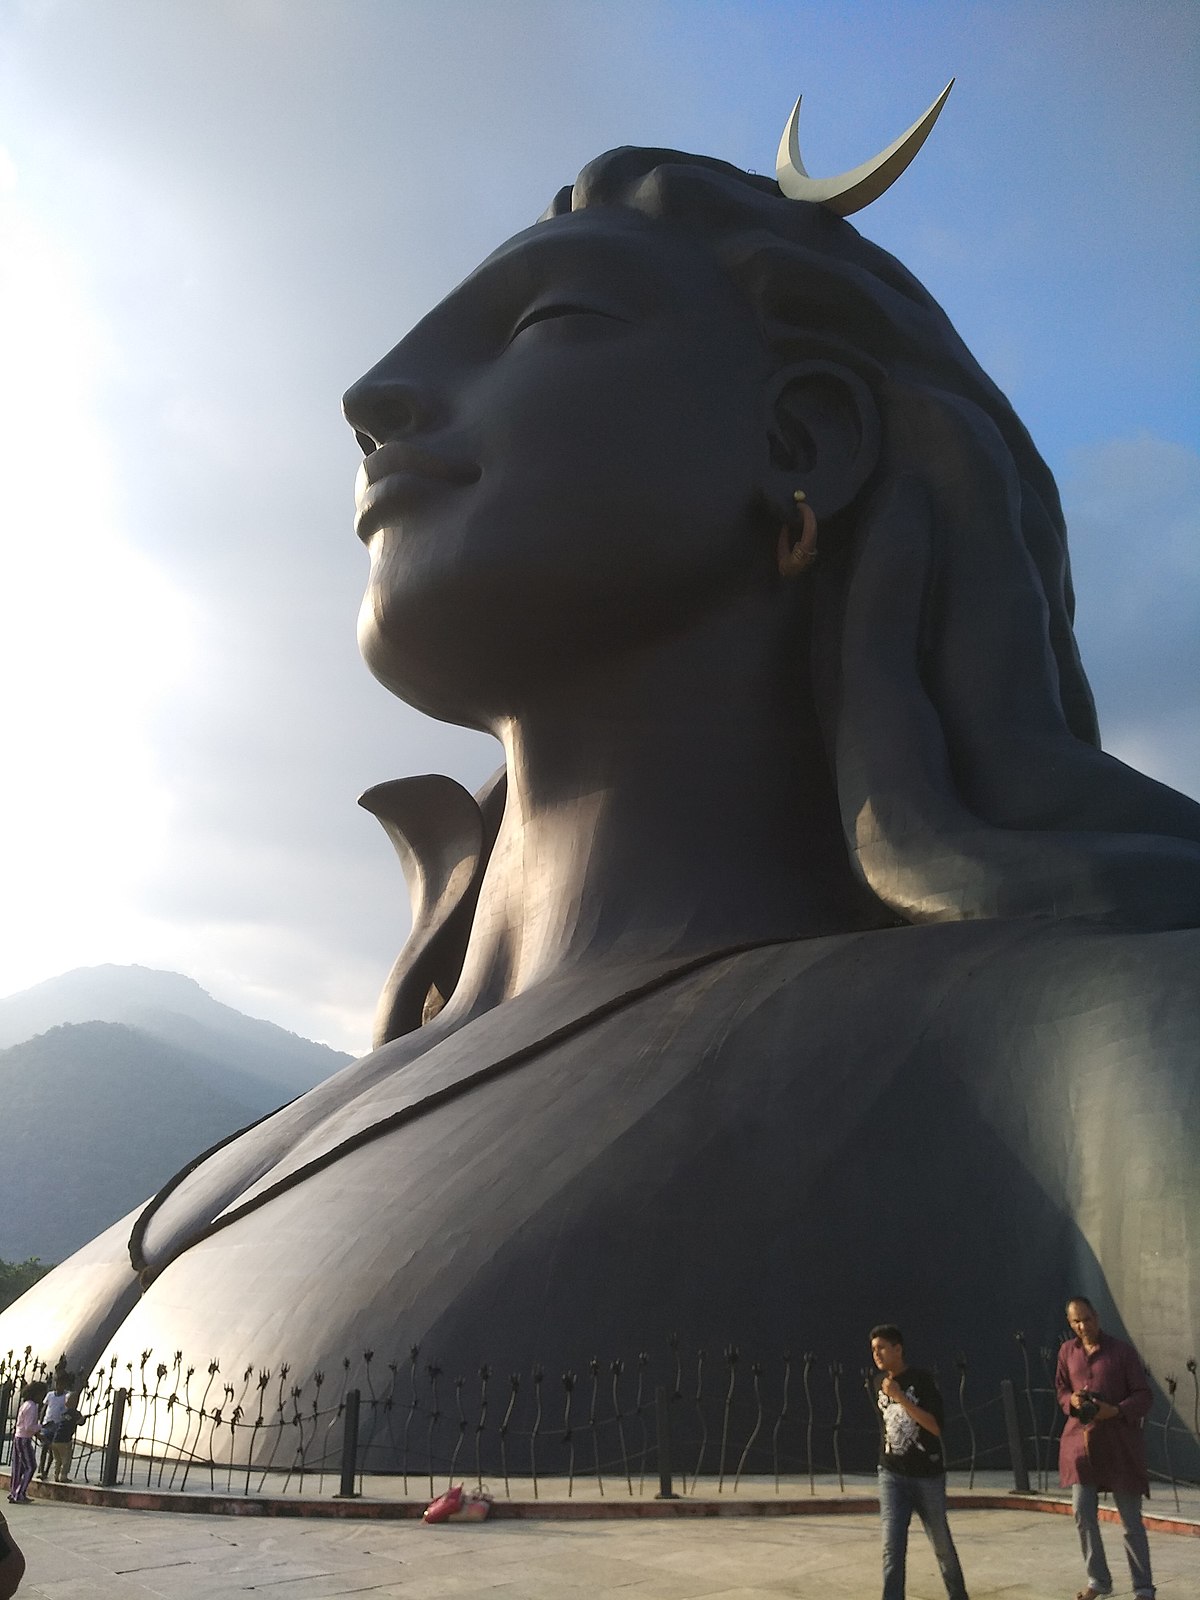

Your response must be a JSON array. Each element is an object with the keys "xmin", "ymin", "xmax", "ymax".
[{"xmin": 1054, "ymin": 1294, "xmax": 1154, "ymax": 1600}]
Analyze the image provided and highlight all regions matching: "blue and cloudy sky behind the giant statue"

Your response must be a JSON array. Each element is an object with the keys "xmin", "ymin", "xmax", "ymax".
[{"xmin": 0, "ymin": 0, "xmax": 1200, "ymax": 1053}]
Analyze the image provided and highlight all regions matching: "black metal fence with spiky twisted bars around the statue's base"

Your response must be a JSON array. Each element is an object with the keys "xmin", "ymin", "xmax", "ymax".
[{"xmin": 0, "ymin": 1334, "xmax": 1200, "ymax": 1504}]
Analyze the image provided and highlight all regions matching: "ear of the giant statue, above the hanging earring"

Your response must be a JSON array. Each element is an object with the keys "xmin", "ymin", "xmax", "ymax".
[{"xmin": 766, "ymin": 362, "xmax": 880, "ymax": 520}]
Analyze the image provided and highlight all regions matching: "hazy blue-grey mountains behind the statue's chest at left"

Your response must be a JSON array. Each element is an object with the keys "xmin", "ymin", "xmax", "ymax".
[{"xmin": 0, "ymin": 966, "xmax": 350, "ymax": 1261}]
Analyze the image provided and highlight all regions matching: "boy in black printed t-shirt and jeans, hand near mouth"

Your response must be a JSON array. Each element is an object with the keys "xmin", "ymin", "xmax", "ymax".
[{"xmin": 870, "ymin": 1322, "xmax": 968, "ymax": 1600}]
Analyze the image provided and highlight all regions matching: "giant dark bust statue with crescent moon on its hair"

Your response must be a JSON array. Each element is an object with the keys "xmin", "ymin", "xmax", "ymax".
[{"xmin": 0, "ymin": 93, "xmax": 1200, "ymax": 1433}]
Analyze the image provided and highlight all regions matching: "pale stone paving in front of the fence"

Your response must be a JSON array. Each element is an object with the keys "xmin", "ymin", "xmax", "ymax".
[{"xmin": 5, "ymin": 1501, "xmax": 1200, "ymax": 1600}]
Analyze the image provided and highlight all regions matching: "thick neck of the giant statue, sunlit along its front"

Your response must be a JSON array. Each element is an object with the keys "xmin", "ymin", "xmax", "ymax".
[{"xmin": 441, "ymin": 595, "xmax": 878, "ymax": 1014}]
